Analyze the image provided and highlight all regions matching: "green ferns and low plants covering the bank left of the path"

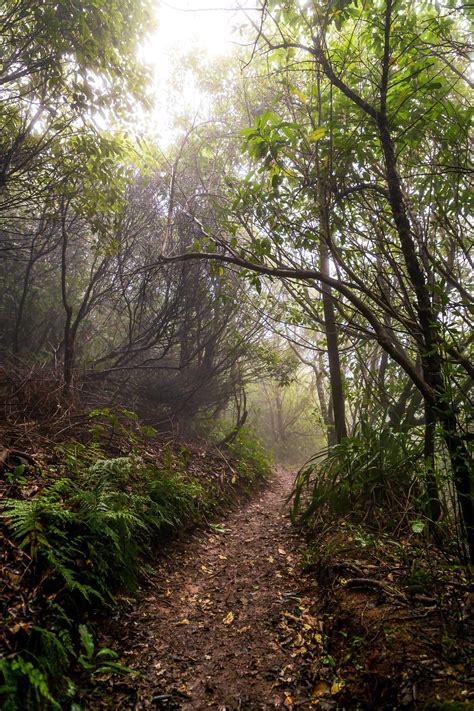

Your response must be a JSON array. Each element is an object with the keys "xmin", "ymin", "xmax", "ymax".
[{"xmin": 0, "ymin": 426, "xmax": 269, "ymax": 711}]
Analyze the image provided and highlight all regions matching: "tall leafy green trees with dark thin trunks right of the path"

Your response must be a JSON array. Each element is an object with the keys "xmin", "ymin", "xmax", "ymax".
[{"xmin": 214, "ymin": 0, "xmax": 474, "ymax": 560}]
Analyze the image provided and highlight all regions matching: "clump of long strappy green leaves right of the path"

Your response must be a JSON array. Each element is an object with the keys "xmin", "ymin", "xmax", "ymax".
[{"xmin": 292, "ymin": 422, "xmax": 426, "ymax": 530}]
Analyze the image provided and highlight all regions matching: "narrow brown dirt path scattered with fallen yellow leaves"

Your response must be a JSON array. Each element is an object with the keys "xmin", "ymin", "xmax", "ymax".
[{"xmin": 109, "ymin": 470, "xmax": 302, "ymax": 711}]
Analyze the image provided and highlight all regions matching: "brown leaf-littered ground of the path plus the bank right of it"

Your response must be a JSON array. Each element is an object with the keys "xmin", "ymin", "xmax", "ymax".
[{"xmin": 82, "ymin": 470, "xmax": 474, "ymax": 711}]
